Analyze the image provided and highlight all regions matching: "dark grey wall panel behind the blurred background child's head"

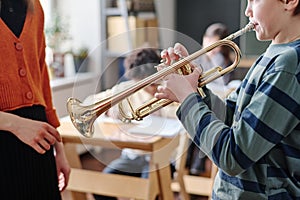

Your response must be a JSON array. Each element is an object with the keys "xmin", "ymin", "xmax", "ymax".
[{"xmin": 175, "ymin": 0, "xmax": 240, "ymax": 47}]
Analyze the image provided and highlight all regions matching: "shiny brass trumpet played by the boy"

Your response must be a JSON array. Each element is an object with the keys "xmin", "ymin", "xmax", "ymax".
[{"xmin": 67, "ymin": 22, "xmax": 254, "ymax": 137}]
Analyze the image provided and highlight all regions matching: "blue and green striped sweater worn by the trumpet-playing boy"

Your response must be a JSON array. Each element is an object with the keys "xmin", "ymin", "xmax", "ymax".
[{"xmin": 177, "ymin": 41, "xmax": 300, "ymax": 200}]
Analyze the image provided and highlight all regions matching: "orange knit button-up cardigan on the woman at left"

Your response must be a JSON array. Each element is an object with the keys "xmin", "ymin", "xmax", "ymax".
[{"xmin": 0, "ymin": 0, "xmax": 59, "ymax": 127}]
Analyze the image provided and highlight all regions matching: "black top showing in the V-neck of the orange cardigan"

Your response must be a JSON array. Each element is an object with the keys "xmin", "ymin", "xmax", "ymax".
[{"xmin": 0, "ymin": 0, "xmax": 27, "ymax": 37}]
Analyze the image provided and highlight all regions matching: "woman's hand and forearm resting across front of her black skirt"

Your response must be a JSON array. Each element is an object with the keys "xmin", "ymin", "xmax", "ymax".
[{"xmin": 0, "ymin": 112, "xmax": 61, "ymax": 154}]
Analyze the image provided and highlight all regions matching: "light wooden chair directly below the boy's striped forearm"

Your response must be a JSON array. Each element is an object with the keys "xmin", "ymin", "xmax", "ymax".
[{"xmin": 171, "ymin": 136, "xmax": 218, "ymax": 200}]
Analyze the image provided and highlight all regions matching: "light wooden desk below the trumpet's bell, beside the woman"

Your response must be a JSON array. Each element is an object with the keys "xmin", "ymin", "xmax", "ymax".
[{"xmin": 59, "ymin": 119, "xmax": 179, "ymax": 200}]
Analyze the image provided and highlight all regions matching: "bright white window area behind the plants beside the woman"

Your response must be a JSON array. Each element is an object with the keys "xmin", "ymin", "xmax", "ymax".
[{"xmin": 56, "ymin": 0, "xmax": 101, "ymax": 73}]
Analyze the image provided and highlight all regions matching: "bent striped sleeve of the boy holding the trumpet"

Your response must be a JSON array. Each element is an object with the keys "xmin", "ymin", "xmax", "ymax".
[{"xmin": 178, "ymin": 47, "xmax": 300, "ymax": 175}]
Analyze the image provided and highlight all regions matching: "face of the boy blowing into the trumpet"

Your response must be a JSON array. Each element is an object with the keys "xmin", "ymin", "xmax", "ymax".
[{"xmin": 245, "ymin": 0, "xmax": 288, "ymax": 41}]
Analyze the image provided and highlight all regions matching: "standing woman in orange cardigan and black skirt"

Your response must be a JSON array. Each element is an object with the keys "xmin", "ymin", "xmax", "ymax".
[{"xmin": 0, "ymin": 0, "xmax": 70, "ymax": 200}]
